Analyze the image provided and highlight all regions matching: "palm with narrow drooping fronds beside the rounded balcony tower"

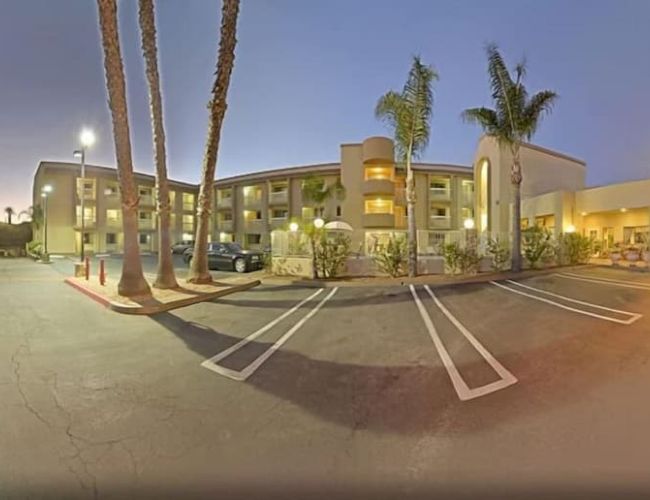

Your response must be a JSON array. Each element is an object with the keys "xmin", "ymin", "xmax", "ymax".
[{"xmin": 375, "ymin": 56, "xmax": 438, "ymax": 282}]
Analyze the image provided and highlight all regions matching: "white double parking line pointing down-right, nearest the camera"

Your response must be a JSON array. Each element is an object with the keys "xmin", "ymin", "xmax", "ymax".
[{"xmin": 410, "ymin": 285, "xmax": 517, "ymax": 401}]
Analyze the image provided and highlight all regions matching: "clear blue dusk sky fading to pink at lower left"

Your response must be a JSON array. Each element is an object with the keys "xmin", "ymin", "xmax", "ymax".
[{"xmin": 0, "ymin": 0, "xmax": 650, "ymax": 211}]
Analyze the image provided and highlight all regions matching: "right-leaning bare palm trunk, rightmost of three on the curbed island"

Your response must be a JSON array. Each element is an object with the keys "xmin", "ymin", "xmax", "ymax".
[{"xmin": 188, "ymin": 0, "xmax": 239, "ymax": 283}]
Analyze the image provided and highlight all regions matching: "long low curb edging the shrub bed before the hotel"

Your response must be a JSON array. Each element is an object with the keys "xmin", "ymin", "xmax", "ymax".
[{"xmin": 262, "ymin": 264, "xmax": 599, "ymax": 288}]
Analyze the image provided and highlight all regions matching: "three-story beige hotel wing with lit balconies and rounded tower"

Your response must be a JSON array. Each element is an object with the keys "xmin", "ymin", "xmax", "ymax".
[{"xmin": 33, "ymin": 137, "xmax": 475, "ymax": 253}]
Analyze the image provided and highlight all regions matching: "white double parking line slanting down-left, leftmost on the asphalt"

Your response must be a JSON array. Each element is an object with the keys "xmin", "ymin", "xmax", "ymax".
[{"xmin": 201, "ymin": 287, "xmax": 338, "ymax": 381}]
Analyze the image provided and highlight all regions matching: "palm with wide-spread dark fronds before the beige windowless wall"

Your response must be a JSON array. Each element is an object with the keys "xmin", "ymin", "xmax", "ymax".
[{"xmin": 462, "ymin": 44, "xmax": 557, "ymax": 272}]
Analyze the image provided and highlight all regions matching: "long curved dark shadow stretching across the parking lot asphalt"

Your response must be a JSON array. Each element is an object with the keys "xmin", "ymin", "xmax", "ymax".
[{"xmin": 151, "ymin": 313, "xmax": 636, "ymax": 436}]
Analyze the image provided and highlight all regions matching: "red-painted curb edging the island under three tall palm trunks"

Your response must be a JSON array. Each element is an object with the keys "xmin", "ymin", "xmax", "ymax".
[{"xmin": 64, "ymin": 278, "xmax": 260, "ymax": 315}]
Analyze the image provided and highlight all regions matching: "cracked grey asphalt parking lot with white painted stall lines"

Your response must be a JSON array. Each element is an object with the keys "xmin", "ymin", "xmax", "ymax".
[{"xmin": 0, "ymin": 260, "xmax": 650, "ymax": 498}]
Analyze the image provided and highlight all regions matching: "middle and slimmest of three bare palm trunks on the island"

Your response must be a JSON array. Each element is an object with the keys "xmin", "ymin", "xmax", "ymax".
[{"xmin": 139, "ymin": 0, "xmax": 178, "ymax": 288}]
